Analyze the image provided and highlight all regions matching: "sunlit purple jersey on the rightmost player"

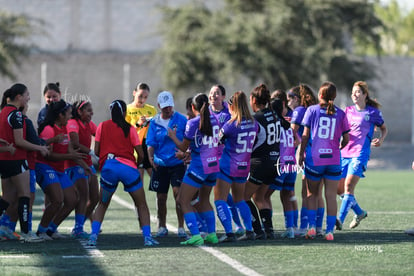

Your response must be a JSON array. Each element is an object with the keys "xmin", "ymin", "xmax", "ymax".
[{"xmin": 341, "ymin": 105, "xmax": 384, "ymax": 158}]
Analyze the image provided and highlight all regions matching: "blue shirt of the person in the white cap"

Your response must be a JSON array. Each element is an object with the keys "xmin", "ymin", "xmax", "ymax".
[{"xmin": 146, "ymin": 112, "xmax": 187, "ymax": 167}]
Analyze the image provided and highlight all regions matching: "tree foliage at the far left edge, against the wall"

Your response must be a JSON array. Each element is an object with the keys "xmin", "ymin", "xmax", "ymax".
[{"xmin": 0, "ymin": 11, "xmax": 41, "ymax": 79}]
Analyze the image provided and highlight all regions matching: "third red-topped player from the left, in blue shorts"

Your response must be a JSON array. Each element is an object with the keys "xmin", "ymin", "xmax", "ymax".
[{"xmin": 65, "ymin": 101, "xmax": 99, "ymax": 239}]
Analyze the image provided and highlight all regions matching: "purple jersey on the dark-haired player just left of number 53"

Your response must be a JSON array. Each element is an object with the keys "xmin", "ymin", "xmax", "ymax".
[{"xmin": 184, "ymin": 115, "xmax": 220, "ymax": 174}]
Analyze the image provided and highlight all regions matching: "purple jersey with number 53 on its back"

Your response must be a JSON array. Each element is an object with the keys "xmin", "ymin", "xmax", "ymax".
[{"xmin": 219, "ymin": 120, "xmax": 258, "ymax": 177}]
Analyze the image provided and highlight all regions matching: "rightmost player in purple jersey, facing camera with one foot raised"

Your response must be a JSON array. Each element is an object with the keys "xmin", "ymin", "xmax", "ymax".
[{"xmin": 338, "ymin": 81, "xmax": 388, "ymax": 228}]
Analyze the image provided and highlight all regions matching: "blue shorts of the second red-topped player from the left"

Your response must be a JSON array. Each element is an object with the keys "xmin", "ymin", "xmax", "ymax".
[{"xmin": 36, "ymin": 163, "xmax": 73, "ymax": 191}]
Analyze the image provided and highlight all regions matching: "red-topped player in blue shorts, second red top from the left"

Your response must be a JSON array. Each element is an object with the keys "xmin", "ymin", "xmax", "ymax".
[{"xmin": 36, "ymin": 100, "xmax": 90, "ymax": 240}]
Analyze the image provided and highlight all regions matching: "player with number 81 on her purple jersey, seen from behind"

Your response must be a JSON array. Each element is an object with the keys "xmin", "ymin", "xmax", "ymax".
[{"xmin": 299, "ymin": 82, "xmax": 349, "ymax": 241}]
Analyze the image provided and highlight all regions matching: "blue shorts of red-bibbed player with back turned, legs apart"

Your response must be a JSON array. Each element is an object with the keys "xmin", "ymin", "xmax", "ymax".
[{"xmin": 101, "ymin": 159, "xmax": 142, "ymax": 193}]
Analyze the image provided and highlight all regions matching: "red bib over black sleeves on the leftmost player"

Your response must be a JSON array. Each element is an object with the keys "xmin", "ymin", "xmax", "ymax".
[{"xmin": 0, "ymin": 105, "xmax": 27, "ymax": 160}]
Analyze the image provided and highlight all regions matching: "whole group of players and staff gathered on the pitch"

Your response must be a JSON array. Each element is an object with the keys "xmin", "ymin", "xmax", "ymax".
[{"xmin": 0, "ymin": 81, "xmax": 387, "ymax": 246}]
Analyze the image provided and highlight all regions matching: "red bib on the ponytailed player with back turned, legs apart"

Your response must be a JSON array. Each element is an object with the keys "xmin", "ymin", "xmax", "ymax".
[{"xmin": 95, "ymin": 120, "xmax": 141, "ymax": 169}]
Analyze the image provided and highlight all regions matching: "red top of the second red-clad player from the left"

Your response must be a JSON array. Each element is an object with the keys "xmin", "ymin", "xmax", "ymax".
[{"xmin": 37, "ymin": 124, "xmax": 69, "ymax": 172}]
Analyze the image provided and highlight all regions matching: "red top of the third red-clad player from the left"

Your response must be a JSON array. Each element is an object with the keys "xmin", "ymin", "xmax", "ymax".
[{"xmin": 65, "ymin": 119, "xmax": 96, "ymax": 169}]
